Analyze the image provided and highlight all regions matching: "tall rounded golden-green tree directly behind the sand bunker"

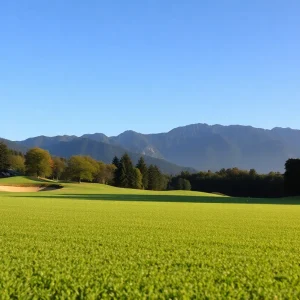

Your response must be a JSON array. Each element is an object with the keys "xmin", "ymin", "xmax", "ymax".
[{"xmin": 25, "ymin": 148, "xmax": 52, "ymax": 177}]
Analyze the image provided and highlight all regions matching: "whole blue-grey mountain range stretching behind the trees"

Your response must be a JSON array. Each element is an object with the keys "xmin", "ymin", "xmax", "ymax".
[{"xmin": 1, "ymin": 124, "xmax": 300, "ymax": 174}]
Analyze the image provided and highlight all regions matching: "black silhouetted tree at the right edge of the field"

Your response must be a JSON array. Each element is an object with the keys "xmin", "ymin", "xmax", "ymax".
[{"xmin": 284, "ymin": 159, "xmax": 300, "ymax": 196}]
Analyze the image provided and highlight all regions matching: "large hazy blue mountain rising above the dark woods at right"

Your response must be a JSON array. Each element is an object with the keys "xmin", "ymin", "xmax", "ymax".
[{"xmin": 110, "ymin": 124, "xmax": 300, "ymax": 172}]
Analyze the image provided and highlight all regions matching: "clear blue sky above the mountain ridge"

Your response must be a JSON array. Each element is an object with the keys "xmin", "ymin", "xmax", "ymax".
[{"xmin": 0, "ymin": 0, "xmax": 300, "ymax": 140}]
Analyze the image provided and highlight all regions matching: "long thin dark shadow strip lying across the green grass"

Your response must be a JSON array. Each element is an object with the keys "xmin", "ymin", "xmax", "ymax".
[{"xmin": 14, "ymin": 194, "xmax": 300, "ymax": 205}]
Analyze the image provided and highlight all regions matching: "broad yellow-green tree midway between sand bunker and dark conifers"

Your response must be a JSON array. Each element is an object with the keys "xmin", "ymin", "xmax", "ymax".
[{"xmin": 66, "ymin": 155, "xmax": 97, "ymax": 183}]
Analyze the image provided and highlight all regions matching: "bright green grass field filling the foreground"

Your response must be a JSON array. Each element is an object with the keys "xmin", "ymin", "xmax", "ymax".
[{"xmin": 0, "ymin": 178, "xmax": 300, "ymax": 299}]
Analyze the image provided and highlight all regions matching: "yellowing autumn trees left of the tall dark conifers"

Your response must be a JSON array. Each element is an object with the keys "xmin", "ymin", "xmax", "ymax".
[{"xmin": 0, "ymin": 143, "xmax": 115, "ymax": 184}]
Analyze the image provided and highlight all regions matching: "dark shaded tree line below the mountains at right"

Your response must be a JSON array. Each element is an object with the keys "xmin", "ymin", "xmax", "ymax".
[{"xmin": 171, "ymin": 159, "xmax": 300, "ymax": 198}]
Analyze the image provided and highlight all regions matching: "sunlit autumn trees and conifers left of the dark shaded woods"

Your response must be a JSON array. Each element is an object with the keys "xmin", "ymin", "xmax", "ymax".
[{"xmin": 0, "ymin": 143, "xmax": 169, "ymax": 190}]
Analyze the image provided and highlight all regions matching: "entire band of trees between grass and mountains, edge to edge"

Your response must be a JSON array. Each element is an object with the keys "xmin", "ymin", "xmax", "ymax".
[{"xmin": 0, "ymin": 143, "xmax": 300, "ymax": 198}]
